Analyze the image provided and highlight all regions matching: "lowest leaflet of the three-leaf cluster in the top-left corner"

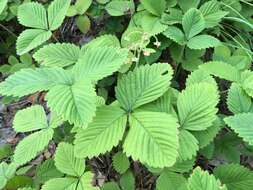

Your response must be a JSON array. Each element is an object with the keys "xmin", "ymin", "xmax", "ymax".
[{"xmin": 16, "ymin": 29, "xmax": 52, "ymax": 55}]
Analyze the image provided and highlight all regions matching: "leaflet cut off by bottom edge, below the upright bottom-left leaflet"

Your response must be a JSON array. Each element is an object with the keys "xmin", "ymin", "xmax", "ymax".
[{"xmin": 41, "ymin": 177, "xmax": 78, "ymax": 190}]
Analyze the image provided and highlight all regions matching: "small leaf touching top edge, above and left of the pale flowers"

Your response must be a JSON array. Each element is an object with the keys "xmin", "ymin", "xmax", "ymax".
[{"xmin": 105, "ymin": 0, "xmax": 135, "ymax": 16}]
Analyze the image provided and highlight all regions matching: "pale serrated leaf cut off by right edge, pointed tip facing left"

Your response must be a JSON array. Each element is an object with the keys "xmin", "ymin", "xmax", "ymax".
[{"xmin": 224, "ymin": 113, "xmax": 253, "ymax": 145}]
